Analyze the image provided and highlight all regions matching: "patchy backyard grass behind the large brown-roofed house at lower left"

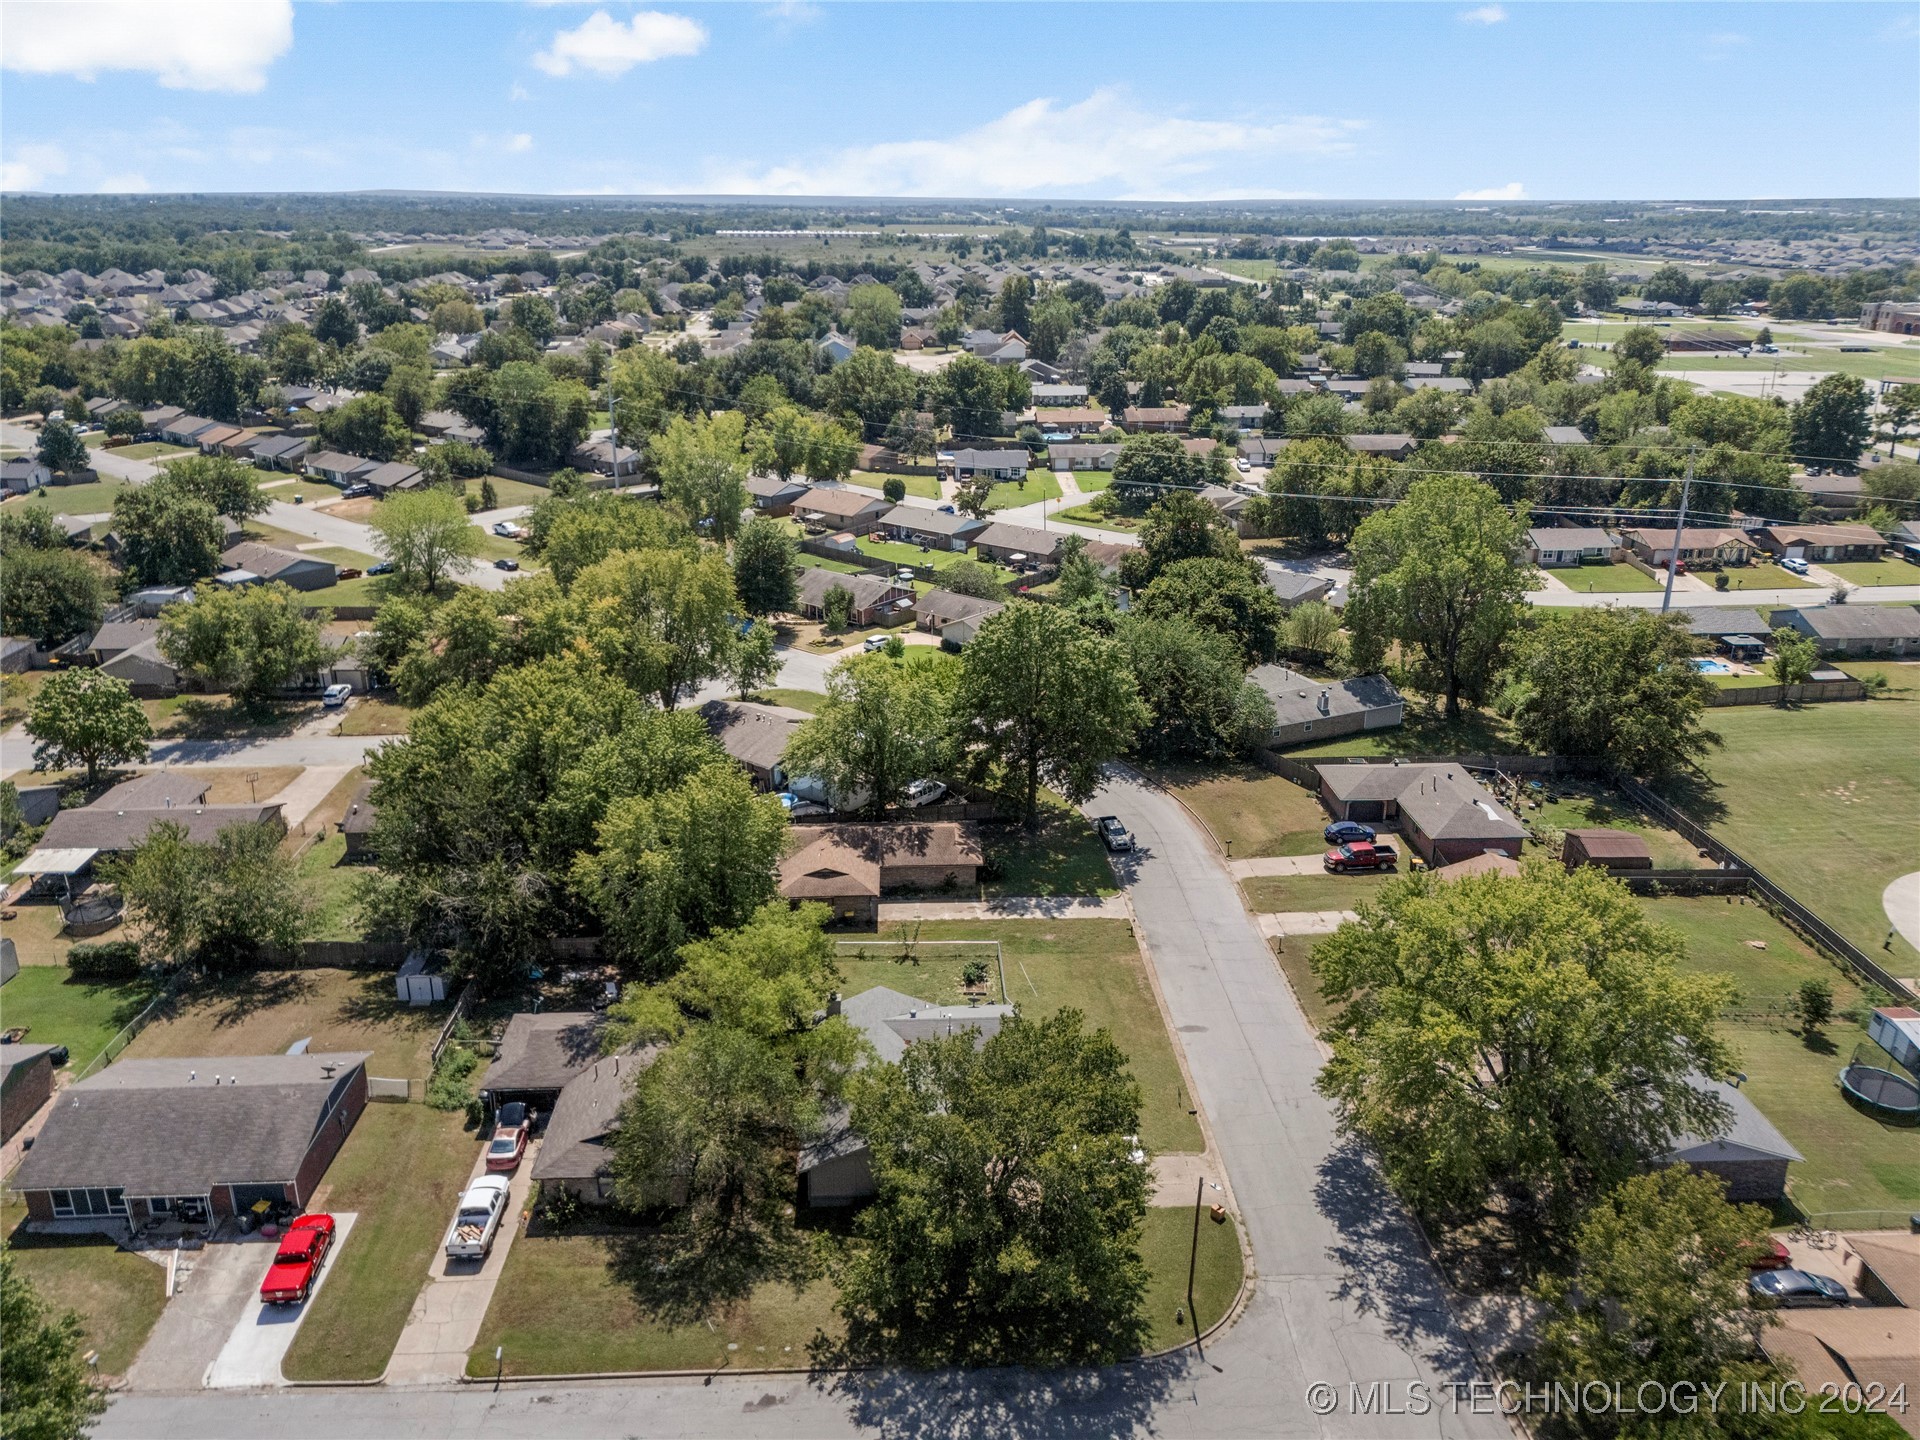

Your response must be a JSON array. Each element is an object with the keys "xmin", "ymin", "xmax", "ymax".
[{"xmin": 127, "ymin": 970, "xmax": 447, "ymax": 1082}]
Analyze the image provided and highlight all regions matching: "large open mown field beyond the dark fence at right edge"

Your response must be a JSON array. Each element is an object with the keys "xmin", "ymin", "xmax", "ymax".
[{"xmin": 1676, "ymin": 660, "xmax": 1920, "ymax": 975}]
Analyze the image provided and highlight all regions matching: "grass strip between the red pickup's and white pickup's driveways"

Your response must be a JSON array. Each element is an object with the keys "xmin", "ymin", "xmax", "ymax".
[{"xmin": 280, "ymin": 1104, "xmax": 476, "ymax": 1380}]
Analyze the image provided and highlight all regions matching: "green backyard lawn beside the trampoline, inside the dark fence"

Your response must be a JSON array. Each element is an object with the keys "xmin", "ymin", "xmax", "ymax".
[{"xmin": 1642, "ymin": 897, "xmax": 1920, "ymax": 1225}]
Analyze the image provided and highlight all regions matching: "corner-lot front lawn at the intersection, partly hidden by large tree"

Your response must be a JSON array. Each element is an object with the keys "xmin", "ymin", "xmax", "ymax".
[{"xmin": 466, "ymin": 1208, "xmax": 1240, "ymax": 1379}]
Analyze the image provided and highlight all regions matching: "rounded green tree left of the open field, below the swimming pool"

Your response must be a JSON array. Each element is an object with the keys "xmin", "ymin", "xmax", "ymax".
[{"xmin": 1513, "ymin": 607, "xmax": 1720, "ymax": 780}]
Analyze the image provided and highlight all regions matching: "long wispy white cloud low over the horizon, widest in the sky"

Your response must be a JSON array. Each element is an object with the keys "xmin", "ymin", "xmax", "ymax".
[{"xmin": 705, "ymin": 88, "xmax": 1359, "ymax": 196}]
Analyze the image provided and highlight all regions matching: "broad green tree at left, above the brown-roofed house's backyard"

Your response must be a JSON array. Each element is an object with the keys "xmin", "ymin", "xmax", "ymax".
[{"xmin": 108, "ymin": 822, "xmax": 313, "ymax": 972}]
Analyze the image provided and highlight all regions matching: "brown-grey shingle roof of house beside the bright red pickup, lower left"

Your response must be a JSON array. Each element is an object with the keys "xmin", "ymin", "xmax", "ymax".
[{"xmin": 13, "ymin": 1050, "xmax": 369, "ymax": 1196}]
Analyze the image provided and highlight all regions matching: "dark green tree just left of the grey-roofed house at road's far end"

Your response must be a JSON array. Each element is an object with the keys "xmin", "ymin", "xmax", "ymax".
[{"xmin": 1119, "ymin": 611, "xmax": 1273, "ymax": 760}]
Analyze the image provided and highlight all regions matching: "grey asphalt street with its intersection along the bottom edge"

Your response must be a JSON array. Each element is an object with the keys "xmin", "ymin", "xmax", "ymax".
[{"xmin": 98, "ymin": 772, "xmax": 1509, "ymax": 1440}]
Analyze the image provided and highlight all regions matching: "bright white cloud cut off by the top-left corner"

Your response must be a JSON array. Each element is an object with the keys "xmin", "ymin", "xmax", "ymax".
[{"xmin": 0, "ymin": 0, "xmax": 294, "ymax": 92}]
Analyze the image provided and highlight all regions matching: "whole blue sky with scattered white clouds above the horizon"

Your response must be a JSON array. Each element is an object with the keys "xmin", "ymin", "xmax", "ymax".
[{"xmin": 0, "ymin": 0, "xmax": 1920, "ymax": 200}]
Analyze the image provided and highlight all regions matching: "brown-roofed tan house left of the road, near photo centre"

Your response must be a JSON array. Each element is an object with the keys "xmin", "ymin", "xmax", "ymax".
[{"xmin": 780, "ymin": 820, "xmax": 981, "ymax": 924}]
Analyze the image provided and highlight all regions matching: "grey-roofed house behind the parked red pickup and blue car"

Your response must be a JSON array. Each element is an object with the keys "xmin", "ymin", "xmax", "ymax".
[{"xmin": 1319, "ymin": 760, "xmax": 1526, "ymax": 866}]
